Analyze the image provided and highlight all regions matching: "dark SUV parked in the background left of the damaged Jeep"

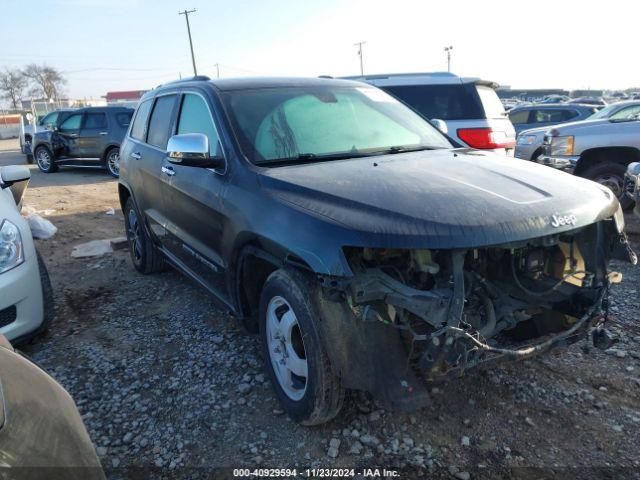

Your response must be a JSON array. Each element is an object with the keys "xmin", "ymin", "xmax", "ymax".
[{"xmin": 32, "ymin": 107, "xmax": 133, "ymax": 177}]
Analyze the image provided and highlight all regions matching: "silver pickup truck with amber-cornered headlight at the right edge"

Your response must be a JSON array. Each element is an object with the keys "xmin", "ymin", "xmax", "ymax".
[{"xmin": 536, "ymin": 115, "xmax": 640, "ymax": 208}]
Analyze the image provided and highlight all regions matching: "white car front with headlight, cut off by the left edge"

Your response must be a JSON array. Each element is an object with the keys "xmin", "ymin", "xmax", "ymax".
[{"xmin": 0, "ymin": 166, "xmax": 53, "ymax": 343}]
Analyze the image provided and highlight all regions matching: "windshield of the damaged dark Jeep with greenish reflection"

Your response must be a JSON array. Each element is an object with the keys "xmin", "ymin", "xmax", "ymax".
[{"xmin": 222, "ymin": 85, "xmax": 452, "ymax": 165}]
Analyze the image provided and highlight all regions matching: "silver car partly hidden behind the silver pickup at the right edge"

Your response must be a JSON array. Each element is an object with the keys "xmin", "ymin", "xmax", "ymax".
[{"xmin": 515, "ymin": 100, "xmax": 640, "ymax": 161}]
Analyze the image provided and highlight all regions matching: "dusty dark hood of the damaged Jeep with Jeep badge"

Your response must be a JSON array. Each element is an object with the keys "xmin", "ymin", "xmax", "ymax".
[{"xmin": 259, "ymin": 149, "xmax": 618, "ymax": 248}]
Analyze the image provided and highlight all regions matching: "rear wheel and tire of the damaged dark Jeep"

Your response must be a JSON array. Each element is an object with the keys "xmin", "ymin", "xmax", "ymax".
[{"xmin": 124, "ymin": 197, "xmax": 166, "ymax": 275}]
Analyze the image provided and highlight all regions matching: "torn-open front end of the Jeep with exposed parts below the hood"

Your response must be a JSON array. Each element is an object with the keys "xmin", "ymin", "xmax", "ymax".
[{"xmin": 321, "ymin": 219, "xmax": 636, "ymax": 407}]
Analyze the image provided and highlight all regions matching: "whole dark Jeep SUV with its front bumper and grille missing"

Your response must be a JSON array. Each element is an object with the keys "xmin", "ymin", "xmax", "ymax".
[{"xmin": 119, "ymin": 77, "xmax": 635, "ymax": 425}]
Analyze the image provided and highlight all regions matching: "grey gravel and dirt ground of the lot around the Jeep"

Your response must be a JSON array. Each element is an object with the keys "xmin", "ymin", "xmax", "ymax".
[{"xmin": 0, "ymin": 140, "xmax": 640, "ymax": 480}]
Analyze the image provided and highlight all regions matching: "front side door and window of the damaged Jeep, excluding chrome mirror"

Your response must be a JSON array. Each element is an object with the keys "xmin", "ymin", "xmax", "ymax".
[{"xmin": 164, "ymin": 91, "xmax": 228, "ymax": 300}]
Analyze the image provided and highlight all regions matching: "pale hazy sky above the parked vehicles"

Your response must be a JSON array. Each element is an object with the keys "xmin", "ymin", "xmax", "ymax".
[{"xmin": 0, "ymin": 0, "xmax": 640, "ymax": 98}]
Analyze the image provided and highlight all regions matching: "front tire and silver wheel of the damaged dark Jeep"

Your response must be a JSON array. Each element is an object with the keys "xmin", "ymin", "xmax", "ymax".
[{"xmin": 260, "ymin": 269, "xmax": 345, "ymax": 425}]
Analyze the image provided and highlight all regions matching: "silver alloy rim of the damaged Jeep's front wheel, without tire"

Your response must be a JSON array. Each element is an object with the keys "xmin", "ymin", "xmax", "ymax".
[{"xmin": 266, "ymin": 296, "xmax": 309, "ymax": 401}]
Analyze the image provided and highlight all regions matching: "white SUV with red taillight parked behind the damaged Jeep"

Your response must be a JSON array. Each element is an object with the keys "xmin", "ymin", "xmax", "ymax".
[{"xmin": 345, "ymin": 72, "xmax": 516, "ymax": 155}]
